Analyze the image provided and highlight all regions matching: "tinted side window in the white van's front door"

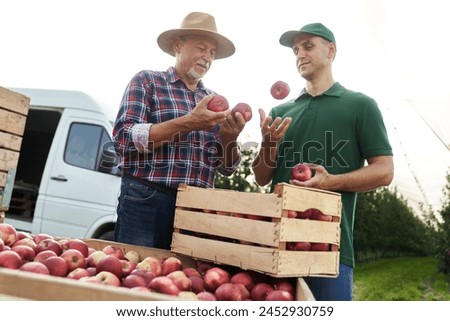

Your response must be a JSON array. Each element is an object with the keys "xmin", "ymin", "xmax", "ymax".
[{"xmin": 64, "ymin": 123, "xmax": 111, "ymax": 171}]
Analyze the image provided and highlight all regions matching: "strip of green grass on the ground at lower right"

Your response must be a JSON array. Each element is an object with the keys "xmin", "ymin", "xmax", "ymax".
[{"xmin": 353, "ymin": 257, "xmax": 450, "ymax": 301}]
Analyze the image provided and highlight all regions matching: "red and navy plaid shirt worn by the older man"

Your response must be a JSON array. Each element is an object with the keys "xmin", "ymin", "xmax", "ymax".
[{"xmin": 113, "ymin": 67, "xmax": 240, "ymax": 188}]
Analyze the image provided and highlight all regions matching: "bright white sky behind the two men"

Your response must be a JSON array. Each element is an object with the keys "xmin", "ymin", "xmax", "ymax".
[{"xmin": 0, "ymin": 0, "xmax": 450, "ymax": 215}]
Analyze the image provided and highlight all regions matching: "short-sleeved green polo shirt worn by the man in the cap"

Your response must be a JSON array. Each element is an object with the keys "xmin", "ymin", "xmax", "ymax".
[{"xmin": 270, "ymin": 83, "xmax": 392, "ymax": 267}]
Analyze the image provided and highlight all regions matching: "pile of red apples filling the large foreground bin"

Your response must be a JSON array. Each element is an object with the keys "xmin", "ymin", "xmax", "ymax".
[{"xmin": 0, "ymin": 223, "xmax": 295, "ymax": 301}]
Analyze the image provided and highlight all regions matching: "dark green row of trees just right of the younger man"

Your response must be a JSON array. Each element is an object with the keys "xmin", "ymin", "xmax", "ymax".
[{"xmin": 354, "ymin": 187, "xmax": 432, "ymax": 261}]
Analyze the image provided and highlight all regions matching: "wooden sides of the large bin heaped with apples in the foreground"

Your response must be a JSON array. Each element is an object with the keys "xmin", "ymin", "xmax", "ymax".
[{"xmin": 0, "ymin": 239, "xmax": 315, "ymax": 301}]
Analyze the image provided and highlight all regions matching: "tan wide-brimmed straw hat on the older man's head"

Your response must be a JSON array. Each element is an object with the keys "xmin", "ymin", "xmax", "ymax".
[{"xmin": 157, "ymin": 12, "xmax": 236, "ymax": 59}]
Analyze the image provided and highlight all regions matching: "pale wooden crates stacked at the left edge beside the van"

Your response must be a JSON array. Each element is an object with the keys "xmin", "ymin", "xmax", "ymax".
[{"xmin": 0, "ymin": 87, "xmax": 30, "ymax": 222}]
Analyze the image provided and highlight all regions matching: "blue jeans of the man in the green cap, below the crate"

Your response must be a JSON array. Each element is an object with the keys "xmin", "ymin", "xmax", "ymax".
[{"xmin": 304, "ymin": 264, "xmax": 353, "ymax": 301}]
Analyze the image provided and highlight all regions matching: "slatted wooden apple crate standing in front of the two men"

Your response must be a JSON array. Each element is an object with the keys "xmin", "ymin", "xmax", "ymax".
[{"xmin": 171, "ymin": 183, "xmax": 342, "ymax": 277}]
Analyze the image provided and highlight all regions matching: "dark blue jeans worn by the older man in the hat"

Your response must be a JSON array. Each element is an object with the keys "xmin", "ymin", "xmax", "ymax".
[{"xmin": 114, "ymin": 177, "xmax": 176, "ymax": 249}]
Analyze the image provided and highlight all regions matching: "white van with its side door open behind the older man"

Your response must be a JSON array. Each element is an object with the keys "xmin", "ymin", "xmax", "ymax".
[{"xmin": 5, "ymin": 88, "xmax": 121, "ymax": 240}]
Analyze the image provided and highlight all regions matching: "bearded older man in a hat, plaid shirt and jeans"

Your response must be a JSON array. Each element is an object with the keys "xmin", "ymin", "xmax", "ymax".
[{"xmin": 113, "ymin": 12, "xmax": 245, "ymax": 249}]
